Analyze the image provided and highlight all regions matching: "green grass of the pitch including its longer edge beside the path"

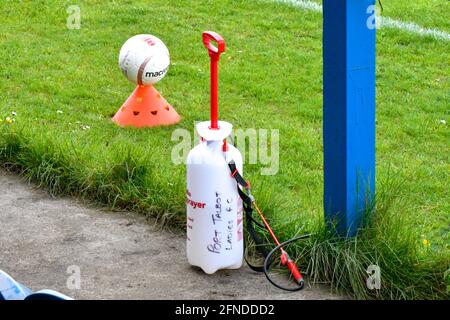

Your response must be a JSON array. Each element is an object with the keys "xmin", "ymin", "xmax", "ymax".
[{"xmin": 0, "ymin": 0, "xmax": 450, "ymax": 298}]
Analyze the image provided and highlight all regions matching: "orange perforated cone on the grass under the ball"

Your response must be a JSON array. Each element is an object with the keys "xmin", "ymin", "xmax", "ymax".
[{"xmin": 112, "ymin": 85, "xmax": 181, "ymax": 128}]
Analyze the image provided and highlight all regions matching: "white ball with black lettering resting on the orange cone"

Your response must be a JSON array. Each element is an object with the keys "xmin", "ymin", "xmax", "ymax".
[{"xmin": 119, "ymin": 34, "xmax": 170, "ymax": 85}]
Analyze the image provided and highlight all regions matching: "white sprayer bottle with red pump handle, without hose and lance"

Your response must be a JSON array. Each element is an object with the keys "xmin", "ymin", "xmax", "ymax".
[{"xmin": 186, "ymin": 31, "xmax": 244, "ymax": 274}]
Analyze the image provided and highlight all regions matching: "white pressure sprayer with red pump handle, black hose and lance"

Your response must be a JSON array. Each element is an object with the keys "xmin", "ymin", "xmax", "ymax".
[{"xmin": 186, "ymin": 31, "xmax": 309, "ymax": 291}]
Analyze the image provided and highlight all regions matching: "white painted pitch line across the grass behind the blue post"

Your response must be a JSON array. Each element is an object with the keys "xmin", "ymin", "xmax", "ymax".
[{"xmin": 272, "ymin": 0, "xmax": 450, "ymax": 41}]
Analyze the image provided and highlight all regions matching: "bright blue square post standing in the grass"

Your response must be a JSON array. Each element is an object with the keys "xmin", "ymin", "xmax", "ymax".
[{"xmin": 323, "ymin": 0, "xmax": 376, "ymax": 236}]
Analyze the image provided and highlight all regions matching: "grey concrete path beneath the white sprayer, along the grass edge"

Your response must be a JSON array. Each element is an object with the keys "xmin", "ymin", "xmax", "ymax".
[{"xmin": 0, "ymin": 170, "xmax": 337, "ymax": 299}]
